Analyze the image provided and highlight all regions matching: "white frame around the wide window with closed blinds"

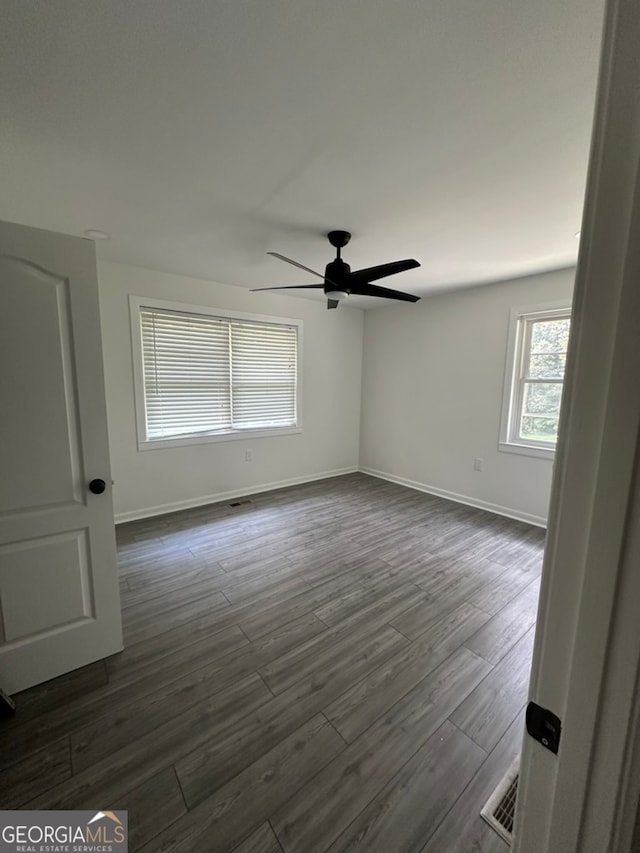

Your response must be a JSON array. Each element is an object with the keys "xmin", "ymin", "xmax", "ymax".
[{"xmin": 129, "ymin": 295, "xmax": 303, "ymax": 450}]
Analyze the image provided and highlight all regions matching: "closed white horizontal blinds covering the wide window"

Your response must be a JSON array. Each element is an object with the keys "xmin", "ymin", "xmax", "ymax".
[{"xmin": 138, "ymin": 305, "xmax": 298, "ymax": 441}]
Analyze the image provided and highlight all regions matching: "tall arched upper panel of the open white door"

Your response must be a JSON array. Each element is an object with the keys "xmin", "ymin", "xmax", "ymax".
[{"xmin": 0, "ymin": 257, "xmax": 81, "ymax": 512}]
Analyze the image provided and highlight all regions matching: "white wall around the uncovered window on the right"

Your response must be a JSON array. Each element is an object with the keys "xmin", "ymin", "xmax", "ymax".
[{"xmin": 360, "ymin": 269, "xmax": 575, "ymax": 524}]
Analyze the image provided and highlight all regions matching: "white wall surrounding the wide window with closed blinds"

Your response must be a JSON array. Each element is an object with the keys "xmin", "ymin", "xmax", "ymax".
[{"xmin": 98, "ymin": 262, "xmax": 363, "ymax": 520}]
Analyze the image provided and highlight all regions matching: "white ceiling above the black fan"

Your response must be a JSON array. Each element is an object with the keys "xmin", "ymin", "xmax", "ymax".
[{"xmin": 0, "ymin": 0, "xmax": 603, "ymax": 305}]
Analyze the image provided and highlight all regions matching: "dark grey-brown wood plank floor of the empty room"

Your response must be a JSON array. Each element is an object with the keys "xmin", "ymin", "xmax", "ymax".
[{"xmin": 0, "ymin": 474, "xmax": 544, "ymax": 853}]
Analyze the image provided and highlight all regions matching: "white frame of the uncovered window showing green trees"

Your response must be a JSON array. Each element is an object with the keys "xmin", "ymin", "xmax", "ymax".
[{"xmin": 498, "ymin": 300, "xmax": 571, "ymax": 460}]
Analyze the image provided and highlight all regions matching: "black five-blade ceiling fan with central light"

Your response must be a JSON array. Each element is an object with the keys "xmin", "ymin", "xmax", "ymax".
[{"xmin": 253, "ymin": 231, "xmax": 420, "ymax": 308}]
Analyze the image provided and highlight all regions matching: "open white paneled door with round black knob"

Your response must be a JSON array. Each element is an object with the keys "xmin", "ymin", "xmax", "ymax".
[{"xmin": 0, "ymin": 222, "xmax": 122, "ymax": 693}]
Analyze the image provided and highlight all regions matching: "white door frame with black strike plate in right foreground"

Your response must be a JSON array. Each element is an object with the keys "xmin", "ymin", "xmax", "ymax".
[{"xmin": 514, "ymin": 0, "xmax": 640, "ymax": 853}]
